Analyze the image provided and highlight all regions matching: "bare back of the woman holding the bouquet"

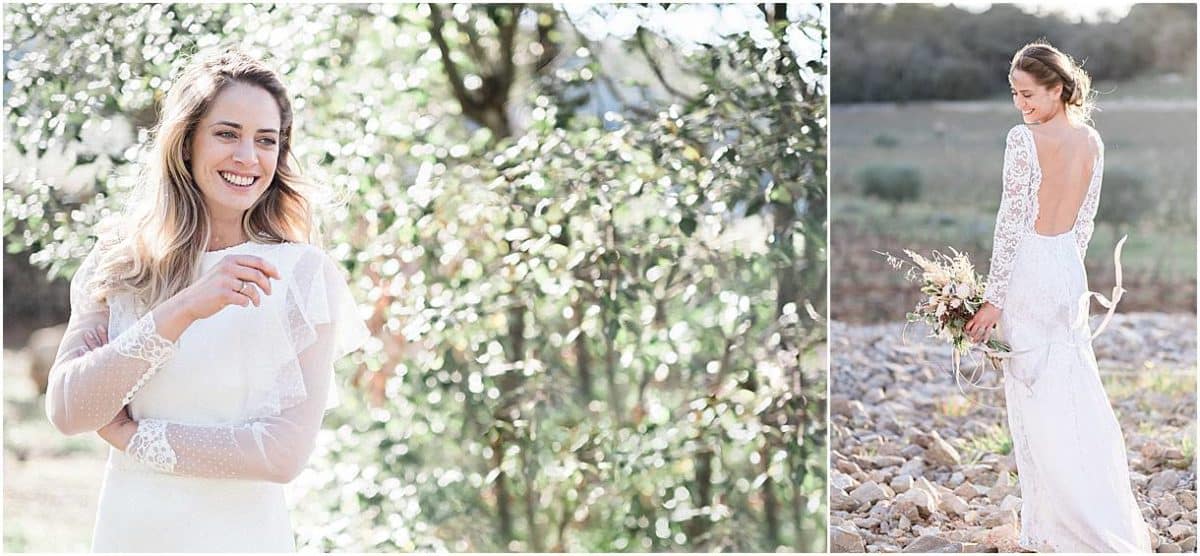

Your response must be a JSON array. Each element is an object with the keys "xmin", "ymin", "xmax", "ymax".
[{"xmin": 1031, "ymin": 127, "xmax": 1099, "ymax": 235}]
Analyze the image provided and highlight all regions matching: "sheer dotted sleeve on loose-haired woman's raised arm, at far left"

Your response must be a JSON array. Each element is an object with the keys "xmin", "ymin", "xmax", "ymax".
[{"xmin": 46, "ymin": 246, "xmax": 175, "ymax": 435}]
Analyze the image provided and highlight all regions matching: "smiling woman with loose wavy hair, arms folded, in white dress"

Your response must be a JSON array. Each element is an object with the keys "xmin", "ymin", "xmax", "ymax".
[{"xmin": 46, "ymin": 49, "xmax": 368, "ymax": 552}]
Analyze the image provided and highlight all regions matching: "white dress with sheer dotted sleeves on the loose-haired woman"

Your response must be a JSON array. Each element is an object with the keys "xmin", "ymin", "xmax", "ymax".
[{"xmin": 47, "ymin": 243, "xmax": 368, "ymax": 552}]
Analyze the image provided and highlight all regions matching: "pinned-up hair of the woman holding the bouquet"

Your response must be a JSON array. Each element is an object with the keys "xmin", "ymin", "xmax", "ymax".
[{"xmin": 1008, "ymin": 41, "xmax": 1096, "ymax": 124}]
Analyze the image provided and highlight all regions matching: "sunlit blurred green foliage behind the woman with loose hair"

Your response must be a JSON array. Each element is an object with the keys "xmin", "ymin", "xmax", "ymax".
[{"xmin": 5, "ymin": 4, "xmax": 827, "ymax": 551}]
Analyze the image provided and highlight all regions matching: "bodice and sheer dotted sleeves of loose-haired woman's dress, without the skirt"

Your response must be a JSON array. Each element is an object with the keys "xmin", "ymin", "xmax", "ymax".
[{"xmin": 48, "ymin": 244, "xmax": 368, "ymax": 483}]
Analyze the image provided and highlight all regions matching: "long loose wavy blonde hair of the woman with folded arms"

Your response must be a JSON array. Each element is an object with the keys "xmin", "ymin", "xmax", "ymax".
[{"xmin": 90, "ymin": 49, "xmax": 316, "ymax": 307}]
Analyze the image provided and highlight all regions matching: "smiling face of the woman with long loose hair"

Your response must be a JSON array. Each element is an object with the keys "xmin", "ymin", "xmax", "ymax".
[{"xmin": 190, "ymin": 83, "xmax": 280, "ymax": 221}]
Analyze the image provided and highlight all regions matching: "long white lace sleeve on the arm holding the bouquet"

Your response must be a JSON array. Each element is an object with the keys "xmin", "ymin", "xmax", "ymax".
[{"xmin": 984, "ymin": 126, "xmax": 1036, "ymax": 309}]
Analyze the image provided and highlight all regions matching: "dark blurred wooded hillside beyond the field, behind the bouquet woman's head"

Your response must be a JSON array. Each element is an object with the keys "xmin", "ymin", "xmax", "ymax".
[{"xmin": 830, "ymin": 4, "xmax": 1196, "ymax": 102}]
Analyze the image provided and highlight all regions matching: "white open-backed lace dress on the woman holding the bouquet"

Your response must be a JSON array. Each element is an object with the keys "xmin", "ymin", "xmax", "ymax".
[{"xmin": 984, "ymin": 125, "xmax": 1150, "ymax": 552}]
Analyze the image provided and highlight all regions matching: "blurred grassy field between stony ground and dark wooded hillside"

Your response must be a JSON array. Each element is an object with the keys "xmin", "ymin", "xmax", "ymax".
[{"xmin": 829, "ymin": 78, "xmax": 1196, "ymax": 322}]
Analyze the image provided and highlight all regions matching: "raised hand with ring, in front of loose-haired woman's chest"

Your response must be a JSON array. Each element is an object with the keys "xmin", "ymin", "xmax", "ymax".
[{"xmin": 155, "ymin": 255, "xmax": 280, "ymax": 341}]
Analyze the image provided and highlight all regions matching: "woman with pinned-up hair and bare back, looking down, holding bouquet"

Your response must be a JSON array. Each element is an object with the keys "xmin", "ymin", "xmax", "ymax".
[{"xmin": 966, "ymin": 42, "xmax": 1151, "ymax": 552}]
